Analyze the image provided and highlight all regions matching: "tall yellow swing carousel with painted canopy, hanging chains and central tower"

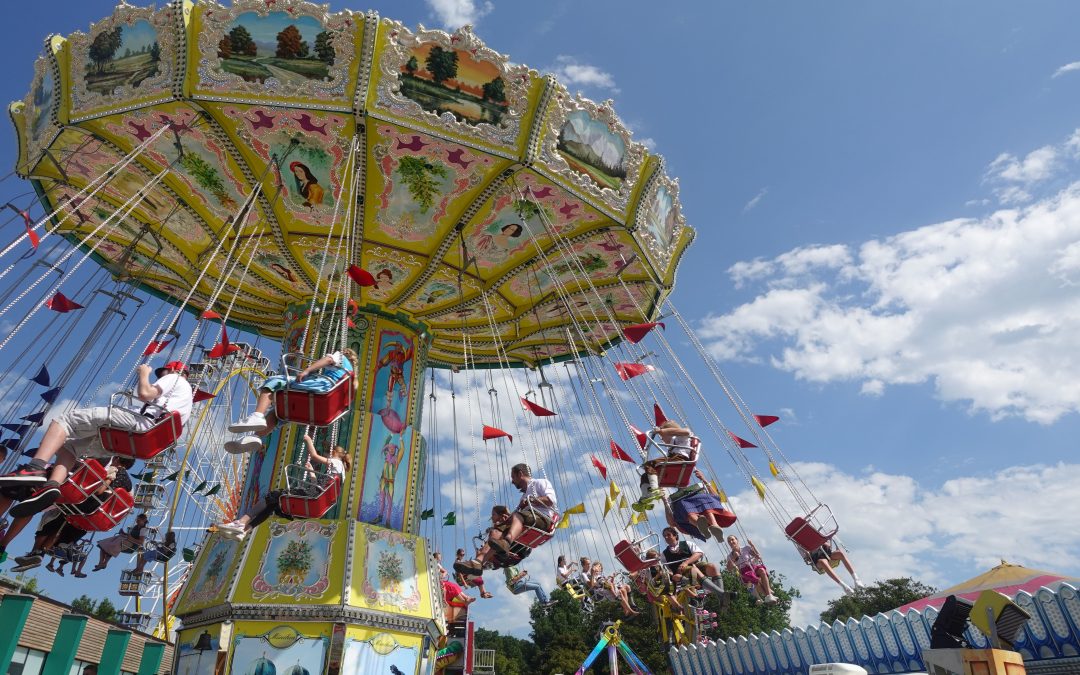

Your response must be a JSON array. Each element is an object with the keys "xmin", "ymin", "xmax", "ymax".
[{"xmin": 0, "ymin": 0, "xmax": 836, "ymax": 672}]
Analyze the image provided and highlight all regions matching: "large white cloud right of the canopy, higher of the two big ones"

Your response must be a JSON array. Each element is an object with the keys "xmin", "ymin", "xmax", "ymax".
[{"xmin": 701, "ymin": 183, "xmax": 1080, "ymax": 423}]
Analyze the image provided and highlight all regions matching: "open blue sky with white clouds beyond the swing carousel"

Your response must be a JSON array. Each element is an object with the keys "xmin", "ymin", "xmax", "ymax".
[{"xmin": 0, "ymin": 0, "xmax": 1080, "ymax": 633}]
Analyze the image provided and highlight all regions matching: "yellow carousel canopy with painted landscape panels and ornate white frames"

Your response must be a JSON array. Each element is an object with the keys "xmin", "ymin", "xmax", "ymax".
[{"xmin": 10, "ymin": 0, "xmax": 692, "ymax": 364}]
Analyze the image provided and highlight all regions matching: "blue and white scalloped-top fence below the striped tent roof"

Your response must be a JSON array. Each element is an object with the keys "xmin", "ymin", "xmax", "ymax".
[{"xmin": 667, "ymin": 582, "xmax": 1080, "ymax": 675}]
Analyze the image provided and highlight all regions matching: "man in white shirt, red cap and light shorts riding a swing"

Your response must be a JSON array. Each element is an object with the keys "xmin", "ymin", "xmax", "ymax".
[{"xmin": 0, "ymin": 361, "xmax": 194, "ymax": 517}]
